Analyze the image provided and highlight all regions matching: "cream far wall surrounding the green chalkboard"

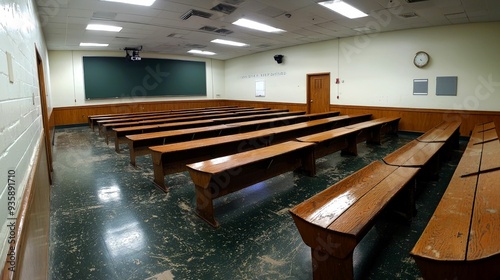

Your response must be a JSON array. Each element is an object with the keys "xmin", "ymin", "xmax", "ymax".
[{"xmin": 49, "ymin": 51, "xmax": 224, "ymax": 107}]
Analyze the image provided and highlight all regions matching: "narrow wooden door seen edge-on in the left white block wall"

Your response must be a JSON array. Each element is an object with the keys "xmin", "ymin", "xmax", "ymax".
[{"xmin": 35, "ymin": 48, "xmax": 53, "ymax": 185}]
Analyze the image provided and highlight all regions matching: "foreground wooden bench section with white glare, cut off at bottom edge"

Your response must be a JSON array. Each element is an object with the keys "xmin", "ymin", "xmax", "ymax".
[{"xmin": 290, "ymin": 161, "xmax": 419, "ymax": 279}]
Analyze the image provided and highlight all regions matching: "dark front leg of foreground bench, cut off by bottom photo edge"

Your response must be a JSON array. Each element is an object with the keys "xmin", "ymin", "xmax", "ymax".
[{"xmin": 311, "ymin": 248, "xmax": 354, "ymax": 280}]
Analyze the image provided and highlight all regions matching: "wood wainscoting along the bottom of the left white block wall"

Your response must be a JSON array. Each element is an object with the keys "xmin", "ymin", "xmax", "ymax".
[{"xmin": 2, "ymin": 133, "xmax": 50, "ymax": 280}]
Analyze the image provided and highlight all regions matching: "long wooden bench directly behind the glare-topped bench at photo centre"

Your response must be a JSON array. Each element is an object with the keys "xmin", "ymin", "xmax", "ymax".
[{"xmin": 149, "ymin": 115, "xmax": 370, "ymax": 191}]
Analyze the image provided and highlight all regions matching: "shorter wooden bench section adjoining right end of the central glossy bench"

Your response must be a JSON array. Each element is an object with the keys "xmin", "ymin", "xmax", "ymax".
[{"xmin": 297, "ymin": 118, "xmax": 400, "ymax": 158}]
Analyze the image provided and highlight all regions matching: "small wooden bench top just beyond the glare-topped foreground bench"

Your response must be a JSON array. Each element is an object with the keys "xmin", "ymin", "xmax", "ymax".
[{"xmin": 384, "ymin": 140, "xmax": 444, "ymax": 167}]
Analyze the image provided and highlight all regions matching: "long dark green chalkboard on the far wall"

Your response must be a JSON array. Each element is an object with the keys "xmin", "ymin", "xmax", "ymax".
[{"xmin": 83, "ymin": 56, "xmax": 207, "ymax": 99}]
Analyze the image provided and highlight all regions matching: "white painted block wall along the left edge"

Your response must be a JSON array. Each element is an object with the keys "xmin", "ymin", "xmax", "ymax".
[{"xmin": 0, "ymin": 0, "xmax": 51, "ymax": 262}]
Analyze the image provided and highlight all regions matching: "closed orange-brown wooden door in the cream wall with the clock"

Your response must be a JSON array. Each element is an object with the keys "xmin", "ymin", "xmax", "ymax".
[{"xmin": 307, "ymin": 73, "xmax": 330, "ymax": 114}]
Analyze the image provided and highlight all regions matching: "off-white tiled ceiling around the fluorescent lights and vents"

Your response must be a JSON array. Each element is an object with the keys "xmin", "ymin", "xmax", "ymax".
[{"xmin": 36, "ymin": 0, "xmax": 500, "ymax": 60}]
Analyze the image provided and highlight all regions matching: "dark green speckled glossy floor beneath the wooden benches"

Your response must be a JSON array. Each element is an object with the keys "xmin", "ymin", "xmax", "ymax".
[{"xmin": 49, "ymin": 126, "xmax": 466, "ymax": 280}]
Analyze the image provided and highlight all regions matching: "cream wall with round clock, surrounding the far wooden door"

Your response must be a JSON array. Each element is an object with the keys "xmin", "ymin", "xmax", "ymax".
[{"xmin": 225, "ymin": 22, "xmax": 500, "ymax": 111}]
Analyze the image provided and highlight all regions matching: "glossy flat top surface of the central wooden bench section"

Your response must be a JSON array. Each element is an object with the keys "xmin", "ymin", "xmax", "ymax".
[{"xmin": 187, "ymin": 141, "xmax": 314, "ymax": 174}]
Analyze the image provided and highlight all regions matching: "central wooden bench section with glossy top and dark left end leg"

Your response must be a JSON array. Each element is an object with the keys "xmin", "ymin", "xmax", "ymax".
[{"xmin": 187, "ymin": 141, "xmax": 316, "ymax": 227}]
